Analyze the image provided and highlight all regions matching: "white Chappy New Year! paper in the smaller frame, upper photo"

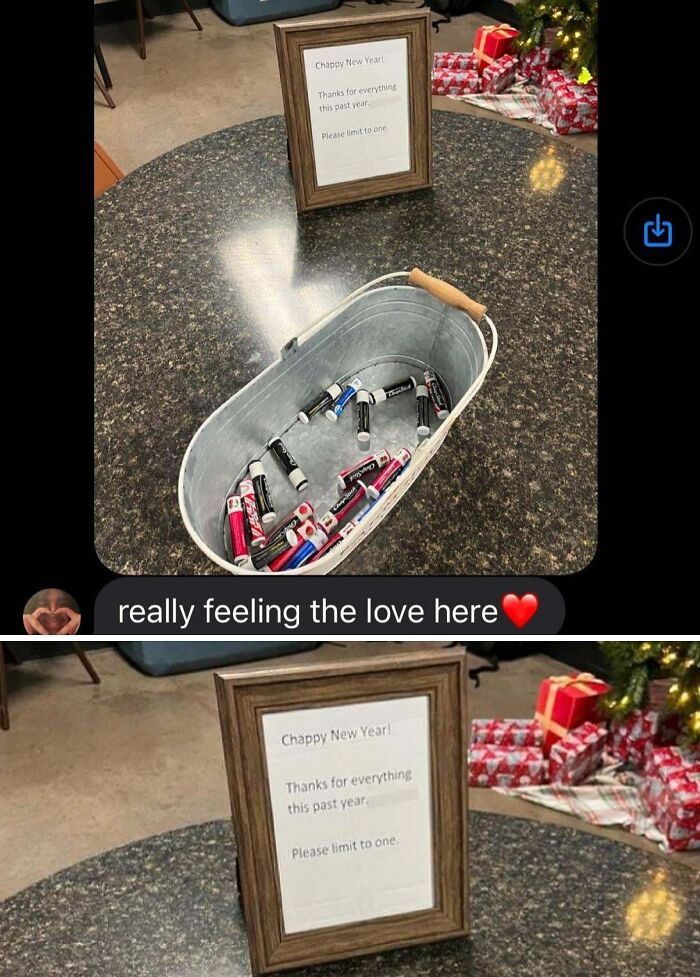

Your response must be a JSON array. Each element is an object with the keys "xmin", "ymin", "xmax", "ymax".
[{"xmin": 304, "ymin": 37, "xmax": 411, "ymax": 187}]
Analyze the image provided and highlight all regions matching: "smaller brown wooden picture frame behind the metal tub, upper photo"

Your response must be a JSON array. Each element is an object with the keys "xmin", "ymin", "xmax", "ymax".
[{"xmin": 275, "ymin": 9, "xmax": 433, "ymax": 212}]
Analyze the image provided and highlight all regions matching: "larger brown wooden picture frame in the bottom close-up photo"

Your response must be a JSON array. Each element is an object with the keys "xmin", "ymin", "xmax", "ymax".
[{"xmin": 215, "ymin": 650, "xmax": 469, "ymax": 974}]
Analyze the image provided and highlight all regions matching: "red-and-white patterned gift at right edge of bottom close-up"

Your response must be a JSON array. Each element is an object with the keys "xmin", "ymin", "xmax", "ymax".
[{"xmin": 640, "ymin": 747, "xmax": 700, "ymax": 851}]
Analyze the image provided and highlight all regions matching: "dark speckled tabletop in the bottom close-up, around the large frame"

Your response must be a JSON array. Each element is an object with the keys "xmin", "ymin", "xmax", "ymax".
[{"xmin": 0, "ymin": 813, "xmax": 700, "ymax": 977}]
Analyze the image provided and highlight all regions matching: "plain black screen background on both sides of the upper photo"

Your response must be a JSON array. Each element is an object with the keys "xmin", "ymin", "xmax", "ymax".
[{"xmin": 0, "ymin": 2, "xmax": 700, "ymax": 634}]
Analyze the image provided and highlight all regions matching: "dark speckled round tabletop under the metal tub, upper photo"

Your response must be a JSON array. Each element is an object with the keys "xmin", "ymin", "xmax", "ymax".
[{"xmin": 95, "ymin": 111, "xmax": 597, "ymax": 574}]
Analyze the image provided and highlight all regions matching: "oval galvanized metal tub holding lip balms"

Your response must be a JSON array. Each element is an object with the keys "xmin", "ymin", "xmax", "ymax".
[{"xmin": 178, "ymin": 272, "xmax": 498, "ymax": 576}]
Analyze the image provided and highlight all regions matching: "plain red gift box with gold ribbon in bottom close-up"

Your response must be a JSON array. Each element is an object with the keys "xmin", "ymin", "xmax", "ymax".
[{"xmin": 535, "ymin": 672, "xmax": 610, "ymax": 756}]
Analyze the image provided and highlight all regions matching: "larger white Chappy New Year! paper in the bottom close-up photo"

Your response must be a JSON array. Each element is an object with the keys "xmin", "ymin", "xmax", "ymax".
[{"xmin": 263, "ymin": 696, "xmax": 435, "ymax": 934}]
